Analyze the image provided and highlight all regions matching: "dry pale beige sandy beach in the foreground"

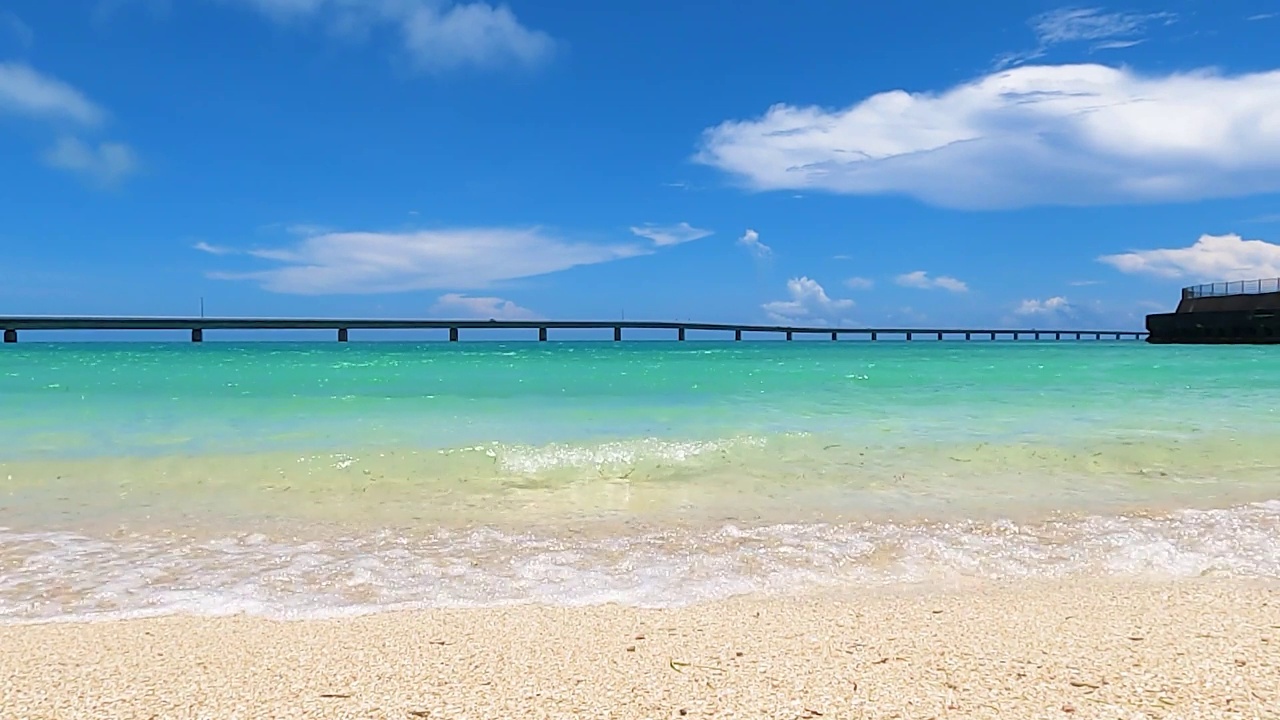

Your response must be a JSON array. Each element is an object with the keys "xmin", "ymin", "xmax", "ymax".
[{"xmin": 0, "ymin": 579, "xmax": 1280, "ymax": 720}]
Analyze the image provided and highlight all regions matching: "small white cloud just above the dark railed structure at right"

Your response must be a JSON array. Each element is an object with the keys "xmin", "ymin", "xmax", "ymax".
[{"xmin": 1098, "ymin": 234, "xmax": 1280, "ymax": 282}]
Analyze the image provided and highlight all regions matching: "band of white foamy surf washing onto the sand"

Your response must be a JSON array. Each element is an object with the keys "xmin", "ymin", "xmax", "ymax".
[{"xmin": 0, "ymin": 501, "xmax": 1280, "ymax": 623}]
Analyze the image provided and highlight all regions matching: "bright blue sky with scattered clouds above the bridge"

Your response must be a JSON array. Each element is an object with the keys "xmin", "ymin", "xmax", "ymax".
[{"xmin": 0, "ymin": 0, "xmax": 1280, "ymax": 329}]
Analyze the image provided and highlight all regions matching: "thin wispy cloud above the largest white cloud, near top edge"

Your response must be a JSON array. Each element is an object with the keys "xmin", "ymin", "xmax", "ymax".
[{"xmin": 996, "ymin": 8, "xmax": 1178, "ymax": 69}]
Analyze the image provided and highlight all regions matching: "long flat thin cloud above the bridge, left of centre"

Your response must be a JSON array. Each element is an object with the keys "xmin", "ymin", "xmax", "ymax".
[{"xmin": 210, "ymin": 228, "xmax": 652, "ymax": 295}]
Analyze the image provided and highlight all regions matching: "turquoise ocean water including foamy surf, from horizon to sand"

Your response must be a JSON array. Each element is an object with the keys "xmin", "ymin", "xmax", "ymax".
[{"xmin": 0, "ymin": 341, "xmax": 1280, "ymax": 623}]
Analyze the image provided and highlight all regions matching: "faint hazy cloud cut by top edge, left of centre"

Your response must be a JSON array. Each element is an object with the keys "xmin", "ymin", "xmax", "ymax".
[{"xmin": 225, "ymin": 0, "xmax": 556, "ymax": 70}]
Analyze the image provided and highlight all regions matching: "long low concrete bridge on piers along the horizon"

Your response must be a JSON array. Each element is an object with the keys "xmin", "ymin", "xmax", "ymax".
[{"xmin": 0, "ymin": 315, "xmax": 1147, "ymax": 342}]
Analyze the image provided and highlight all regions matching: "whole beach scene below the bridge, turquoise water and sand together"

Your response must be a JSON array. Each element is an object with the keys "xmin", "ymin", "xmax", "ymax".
[{"xmin": 0, "ymin": 342, "xmax": 1280, "ymax": 719}]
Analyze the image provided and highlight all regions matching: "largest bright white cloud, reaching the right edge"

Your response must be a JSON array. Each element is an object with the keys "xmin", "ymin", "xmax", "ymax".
[{"xmin": 696, "ymin": 64, "xmax": 1280, "ymax": 209}]
